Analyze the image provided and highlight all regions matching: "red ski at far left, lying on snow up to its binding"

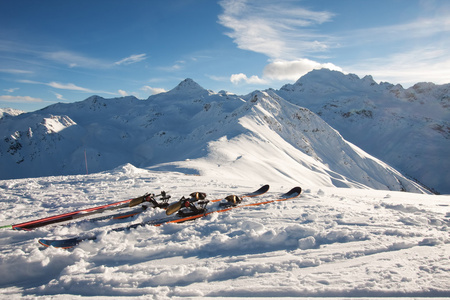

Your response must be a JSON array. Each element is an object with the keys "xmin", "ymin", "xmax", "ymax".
[{"xmin": 9, "ymin": 191, "xmax": 171, "ymax": 231}]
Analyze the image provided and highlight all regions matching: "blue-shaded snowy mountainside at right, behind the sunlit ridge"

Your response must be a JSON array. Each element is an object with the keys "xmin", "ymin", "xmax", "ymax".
[{"xmin": 276, "ymin": 69, "xmax": 450, "ymax": 194}]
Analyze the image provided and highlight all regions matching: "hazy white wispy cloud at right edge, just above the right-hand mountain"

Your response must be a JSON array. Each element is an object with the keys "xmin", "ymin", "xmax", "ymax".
[{"xmin": 342, "ymin": 15, "xmax": 450, "ymax": 87}]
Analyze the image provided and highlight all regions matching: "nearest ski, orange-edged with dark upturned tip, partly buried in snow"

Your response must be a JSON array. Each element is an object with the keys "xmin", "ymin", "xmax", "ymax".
[{"xmin": 39, "ymin": 187, "xmax": 302, "ymax": 249}]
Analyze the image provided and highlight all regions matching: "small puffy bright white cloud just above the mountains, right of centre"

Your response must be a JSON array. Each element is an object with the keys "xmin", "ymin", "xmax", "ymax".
[{"xmin": 263, "ymin": 58, "xmax": 342, "ymax": 80}]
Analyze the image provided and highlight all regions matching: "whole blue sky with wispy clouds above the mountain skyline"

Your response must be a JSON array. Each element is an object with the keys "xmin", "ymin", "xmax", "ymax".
[{"xmin": 0, "ymin": 0, "xmax": 450, "ymax": 111}]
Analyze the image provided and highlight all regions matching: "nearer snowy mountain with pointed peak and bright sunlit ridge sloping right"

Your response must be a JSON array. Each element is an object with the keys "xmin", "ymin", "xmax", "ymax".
[{"xmin": 0, "ymin": 79, "xmax": 425, "ymax": 192}]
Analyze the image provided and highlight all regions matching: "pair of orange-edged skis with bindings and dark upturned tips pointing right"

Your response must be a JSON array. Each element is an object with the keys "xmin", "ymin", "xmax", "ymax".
[{"xmin": 39, "ymin": 185, "xmax": 302, "ymax": 249}]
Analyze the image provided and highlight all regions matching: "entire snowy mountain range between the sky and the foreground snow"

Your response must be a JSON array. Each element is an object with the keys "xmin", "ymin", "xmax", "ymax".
[{"xmin": 0, "ymin": 70, "xmax": 450, "ymax": 193}]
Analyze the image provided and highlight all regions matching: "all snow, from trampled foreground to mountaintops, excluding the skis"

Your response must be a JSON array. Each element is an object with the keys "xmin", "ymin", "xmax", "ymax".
[{"xmin": 0, "ymin": 70, "xmax": 450, "ymax": 299}]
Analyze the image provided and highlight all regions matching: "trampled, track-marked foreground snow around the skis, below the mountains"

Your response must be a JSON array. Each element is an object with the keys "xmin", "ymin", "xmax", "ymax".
[{"xmin": 0, "ymin": 165, "xmax": 450, "ymax": 299}]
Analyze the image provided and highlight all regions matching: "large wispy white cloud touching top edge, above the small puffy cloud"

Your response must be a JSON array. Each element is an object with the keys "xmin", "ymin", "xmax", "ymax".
[{"xmin": 218, "ymin": 0, "xmax": 334, "ymax": 59}]
